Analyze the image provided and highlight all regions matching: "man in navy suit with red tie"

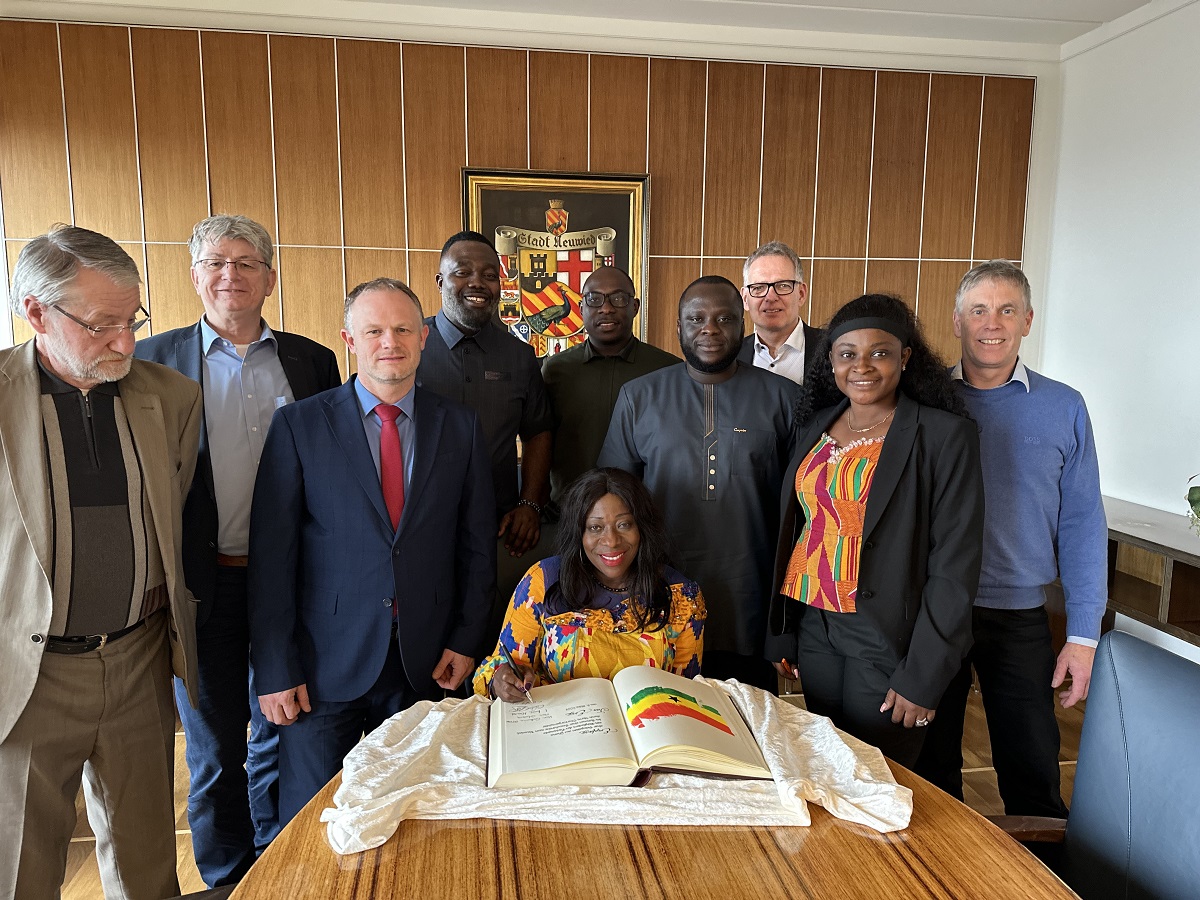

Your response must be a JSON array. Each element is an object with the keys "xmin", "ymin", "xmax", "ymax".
[{"xmin": 250, "ymin": 278, "xmax": 496, "ymax": 823}]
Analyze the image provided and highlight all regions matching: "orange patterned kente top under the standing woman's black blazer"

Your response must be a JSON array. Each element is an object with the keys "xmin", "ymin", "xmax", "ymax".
[{"xmin": 780, "ymin": 434, "xmax": 883, "ymax": 612}]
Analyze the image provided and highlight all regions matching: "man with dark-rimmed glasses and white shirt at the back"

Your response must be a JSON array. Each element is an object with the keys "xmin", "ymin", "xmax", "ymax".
[{"xmin": 738, "ymin": 241, "xmax": 821, "ymax": 384}]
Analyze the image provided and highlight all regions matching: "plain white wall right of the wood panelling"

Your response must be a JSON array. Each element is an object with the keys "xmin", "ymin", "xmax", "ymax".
[{"xmin": 1034, "ymin": 2, "xmax": 1200, "ymax": 512}]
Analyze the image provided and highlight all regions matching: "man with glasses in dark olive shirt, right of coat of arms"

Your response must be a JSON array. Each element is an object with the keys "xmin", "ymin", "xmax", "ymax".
[{"xmin": 541, "ymin": 265, "xmax": 679, "ymax": 504}]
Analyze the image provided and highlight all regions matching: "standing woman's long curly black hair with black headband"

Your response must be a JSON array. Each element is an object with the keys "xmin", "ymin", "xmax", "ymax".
[{"xmin": 796, "ymin": 294, "xmax": 971, "ymax": 426}]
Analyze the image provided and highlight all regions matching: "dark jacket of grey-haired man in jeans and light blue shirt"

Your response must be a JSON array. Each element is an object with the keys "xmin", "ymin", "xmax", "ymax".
[{"xmin": 133, "ymin": 322, "xmax": 342, "ymax": 626}]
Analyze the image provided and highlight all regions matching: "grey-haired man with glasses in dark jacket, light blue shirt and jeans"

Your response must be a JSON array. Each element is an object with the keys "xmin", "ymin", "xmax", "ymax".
[{"xmin": 134, "ymin": 216, "xmax": 342, "ymax": 887}]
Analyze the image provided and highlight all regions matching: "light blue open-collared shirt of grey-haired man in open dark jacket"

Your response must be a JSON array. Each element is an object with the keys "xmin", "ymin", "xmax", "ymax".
[{"xmin": 200, "ymin": 318, "xmax": 295, "ymax": 557}]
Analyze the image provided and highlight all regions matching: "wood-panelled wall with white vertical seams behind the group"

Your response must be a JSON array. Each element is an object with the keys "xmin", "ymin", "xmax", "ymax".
[{"xmin": 0, "ymin": 22, "xmax": 1034, "ymax": 369}]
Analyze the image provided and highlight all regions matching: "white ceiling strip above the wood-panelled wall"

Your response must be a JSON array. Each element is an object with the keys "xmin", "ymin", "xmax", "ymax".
[{"xmin": 348, "ymin": 0, "xmax": 1150, "ymax": 46}]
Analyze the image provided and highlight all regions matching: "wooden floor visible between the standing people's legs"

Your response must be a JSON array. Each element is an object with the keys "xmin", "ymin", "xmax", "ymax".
[{"xmin": 62, "ymin": 691, "xmax": 1084, "ymax": 900}]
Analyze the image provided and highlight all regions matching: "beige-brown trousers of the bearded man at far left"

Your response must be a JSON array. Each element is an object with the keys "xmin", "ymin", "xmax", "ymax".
[{"xmin": 0, "ymin": 612, "xmax": 179, "ymax": 900}]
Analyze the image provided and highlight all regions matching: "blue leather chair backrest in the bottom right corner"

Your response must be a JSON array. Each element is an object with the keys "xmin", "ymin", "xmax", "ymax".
[{"xmin": 1062, "ymin": 631, "xmax": 1200, "ymax": 900}]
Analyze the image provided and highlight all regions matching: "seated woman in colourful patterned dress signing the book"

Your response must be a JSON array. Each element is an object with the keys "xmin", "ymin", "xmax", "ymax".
[{"xmin": 474, "ymin": 469, "xmax": 704, "ymax": 702}]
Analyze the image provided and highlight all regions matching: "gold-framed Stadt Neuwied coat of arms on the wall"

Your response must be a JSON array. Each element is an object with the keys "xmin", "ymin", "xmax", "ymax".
[{"xmin": 462, "ymin": 168, "xmax": 650, "ymax": 356}]
